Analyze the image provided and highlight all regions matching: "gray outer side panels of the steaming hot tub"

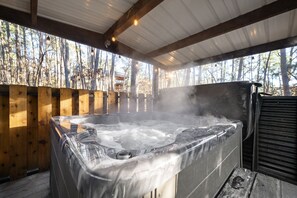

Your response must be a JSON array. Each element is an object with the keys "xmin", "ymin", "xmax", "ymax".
[{"xmin": 51, "ymin": 113, "xmax": 242, "ymax": 197}]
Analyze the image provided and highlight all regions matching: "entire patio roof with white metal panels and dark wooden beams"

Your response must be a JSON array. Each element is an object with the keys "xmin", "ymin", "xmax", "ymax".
[{"xmin": 0, "ymin": 0, "xmax": 297, "ymax": 70}]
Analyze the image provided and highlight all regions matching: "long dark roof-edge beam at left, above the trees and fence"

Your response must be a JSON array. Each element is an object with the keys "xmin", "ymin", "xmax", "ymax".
[{"xmin": 0, "ymin": 5, "xmax": 165, "ymax": 68}]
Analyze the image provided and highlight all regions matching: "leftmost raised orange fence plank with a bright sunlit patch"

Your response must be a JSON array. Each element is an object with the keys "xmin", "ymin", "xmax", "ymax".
[{"xmin": 9, "ymin": 85, "xmax": 27, "ymax": 179}]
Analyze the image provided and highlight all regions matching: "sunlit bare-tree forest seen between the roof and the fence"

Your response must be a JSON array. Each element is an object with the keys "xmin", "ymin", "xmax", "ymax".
[{"xmin": 0, "ymin": 20, "xmax": 297, "ymax": 96}]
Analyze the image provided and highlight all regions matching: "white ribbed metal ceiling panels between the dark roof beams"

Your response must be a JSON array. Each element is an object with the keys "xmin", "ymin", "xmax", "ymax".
[{"xmin": 0, "ymin": 0, "xmax": 297, "ymax": 66}]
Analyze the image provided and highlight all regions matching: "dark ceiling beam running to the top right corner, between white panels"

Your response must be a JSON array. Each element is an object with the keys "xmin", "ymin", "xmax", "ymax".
[{"xmin": 146, "ymin": 0, "xmax": 297, "ymax": 57}]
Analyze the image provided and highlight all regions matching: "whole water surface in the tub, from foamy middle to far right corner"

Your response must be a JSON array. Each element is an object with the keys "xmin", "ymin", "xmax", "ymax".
[{"xmin": 82, "ymin": 113, "xmax": 230, "ymax": 150}]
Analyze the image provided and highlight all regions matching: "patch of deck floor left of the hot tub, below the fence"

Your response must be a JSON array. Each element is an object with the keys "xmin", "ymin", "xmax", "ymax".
[{"xmin": 0, "ymin": 171, "xmax": 51, "ymax": 198}]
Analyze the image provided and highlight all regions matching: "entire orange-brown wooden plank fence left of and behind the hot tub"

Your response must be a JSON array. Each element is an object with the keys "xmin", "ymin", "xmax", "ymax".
[{"xmin": 0, "ymin": 85, "xmax": 152, "ymax": 183}]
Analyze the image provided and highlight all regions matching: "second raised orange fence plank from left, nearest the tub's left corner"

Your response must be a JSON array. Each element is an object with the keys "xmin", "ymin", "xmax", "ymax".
[{"xmin": 38, "ymin": 87, "xmax": 52, "ymax": 171}]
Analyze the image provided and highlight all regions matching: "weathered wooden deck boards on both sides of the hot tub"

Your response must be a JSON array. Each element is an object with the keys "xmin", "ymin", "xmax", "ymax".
[{"xmin": 0, "ymin": 169, "xmax": 297, "ymax": 198}]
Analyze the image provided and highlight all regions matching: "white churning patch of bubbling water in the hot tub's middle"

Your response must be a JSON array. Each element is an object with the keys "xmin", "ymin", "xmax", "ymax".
[{"xmin": 85, "ymin": 120, "xmax": 191, "ymax": 150}]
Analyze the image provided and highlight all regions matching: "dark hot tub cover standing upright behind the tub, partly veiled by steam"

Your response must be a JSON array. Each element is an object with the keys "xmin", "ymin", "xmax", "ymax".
[{"xmin": 154, "ymin": 82, "xmax": 261, "ymax": 140}]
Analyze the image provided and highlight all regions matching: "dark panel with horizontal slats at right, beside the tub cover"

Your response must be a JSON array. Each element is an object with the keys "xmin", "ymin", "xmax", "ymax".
[{"xmin": 256, "ymin": 96, "xmax": 297, "ymax": 184}]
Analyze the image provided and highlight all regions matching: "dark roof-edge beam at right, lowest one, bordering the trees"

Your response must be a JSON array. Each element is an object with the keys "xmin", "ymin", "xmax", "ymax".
[{"xmin": 167, "ymin": 36, "xmax": 297, "ymax": 70}]
